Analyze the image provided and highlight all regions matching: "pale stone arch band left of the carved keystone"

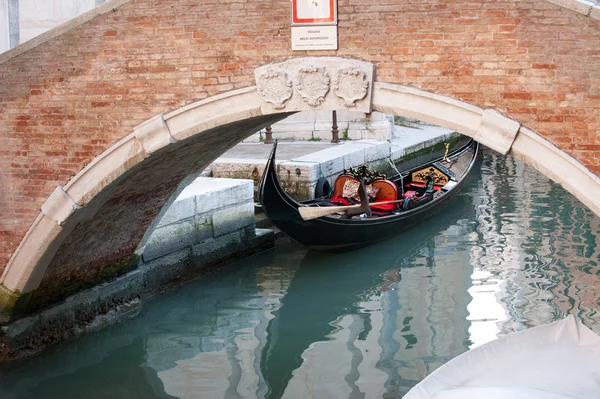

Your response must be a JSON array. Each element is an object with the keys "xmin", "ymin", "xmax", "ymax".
[{"xmin": 0, "ymin": 87, "xmax": 290, "ymax": 318}]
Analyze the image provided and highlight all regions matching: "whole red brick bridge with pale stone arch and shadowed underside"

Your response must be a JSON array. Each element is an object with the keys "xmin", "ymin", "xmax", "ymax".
[{"xmin": 0, "ymin": 0, "xmax": 600, "ymax": 322}]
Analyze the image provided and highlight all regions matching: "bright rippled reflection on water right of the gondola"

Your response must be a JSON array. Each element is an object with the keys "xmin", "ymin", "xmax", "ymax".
[{"xmin": 470, "ymin": 154, "xmax": 600, "ymax": 344}]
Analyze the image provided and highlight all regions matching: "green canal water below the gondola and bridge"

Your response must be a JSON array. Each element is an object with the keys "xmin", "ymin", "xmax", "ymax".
[{"xmin": 0, "ymin": 152, "xmax": 600, "ymax": 399}]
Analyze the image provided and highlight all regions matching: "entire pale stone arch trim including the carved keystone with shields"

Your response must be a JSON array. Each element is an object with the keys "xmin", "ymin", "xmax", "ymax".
[{"xmin": 0, "ymin": 58, "xmax": 600, "ymax": 314}]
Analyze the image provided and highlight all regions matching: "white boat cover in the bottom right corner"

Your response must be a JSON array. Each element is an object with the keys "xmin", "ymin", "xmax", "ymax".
[{"xmin": 403, "ymin": 316, "xmax": 600, "ymax": 399}]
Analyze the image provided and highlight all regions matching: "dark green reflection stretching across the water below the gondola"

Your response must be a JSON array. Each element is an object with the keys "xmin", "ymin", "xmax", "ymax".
[{"xmin": 261, "ymin": 180, "xmax": 480, "ymax": 398}]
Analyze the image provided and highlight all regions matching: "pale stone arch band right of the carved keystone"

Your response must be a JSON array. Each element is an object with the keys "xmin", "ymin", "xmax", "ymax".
[{"xmin": 373, "ymin": 82, "xmax": 600, "ymax": 216}]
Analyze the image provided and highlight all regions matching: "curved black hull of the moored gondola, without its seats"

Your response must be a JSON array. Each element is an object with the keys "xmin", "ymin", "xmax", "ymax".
[{"xmin": 259, "ymin": 142, "xmax": 478, "ymax": 252}]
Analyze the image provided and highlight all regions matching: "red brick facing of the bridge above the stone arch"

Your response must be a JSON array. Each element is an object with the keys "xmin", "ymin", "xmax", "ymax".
[{"xmin": 0, "ymin": 0, "xmax": 600, "ymax": 276}]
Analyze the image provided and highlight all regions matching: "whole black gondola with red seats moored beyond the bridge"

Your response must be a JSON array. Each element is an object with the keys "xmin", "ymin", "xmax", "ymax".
[{"xmin": 258, "ymin": 140, "xmax": 479, "ymax": 252}]
